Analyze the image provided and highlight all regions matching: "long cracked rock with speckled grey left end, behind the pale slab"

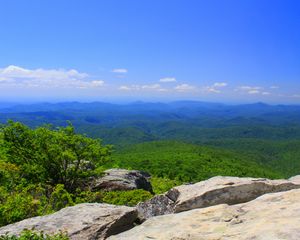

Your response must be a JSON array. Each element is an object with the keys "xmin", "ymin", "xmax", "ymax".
[{"xmin": 137, "ymin": 177, "xmax": 300, "ymax": 221}]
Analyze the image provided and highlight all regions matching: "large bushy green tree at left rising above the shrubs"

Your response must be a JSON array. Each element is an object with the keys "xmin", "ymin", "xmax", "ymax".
[{"xmin": 0, "ymin": 121, "xmax": 111, "ymax": 192}]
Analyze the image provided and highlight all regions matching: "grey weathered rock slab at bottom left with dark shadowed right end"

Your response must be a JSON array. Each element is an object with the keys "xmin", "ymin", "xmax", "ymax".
[{"xmin": 0, "ymin": 203, "xmax": 137, "ymax": 240}]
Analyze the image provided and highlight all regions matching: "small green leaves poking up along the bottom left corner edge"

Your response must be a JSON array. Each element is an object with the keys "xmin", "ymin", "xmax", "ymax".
[{"xmin": 0, "ymin": 230, "xmax": 69, "ymax": 240}]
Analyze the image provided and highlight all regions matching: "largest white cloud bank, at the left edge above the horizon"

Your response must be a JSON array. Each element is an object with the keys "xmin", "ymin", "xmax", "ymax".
[{"xmin": 0, "ymin": 65, "xmax": 104, "ymax": 88}]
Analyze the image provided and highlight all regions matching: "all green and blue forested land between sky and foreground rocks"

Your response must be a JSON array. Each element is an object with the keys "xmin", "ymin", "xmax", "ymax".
[{"xmin": 0, "ymin": 102, "xmax": 300, "ymax": 239}]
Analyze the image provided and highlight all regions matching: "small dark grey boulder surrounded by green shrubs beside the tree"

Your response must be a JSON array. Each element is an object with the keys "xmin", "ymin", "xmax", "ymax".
[{"xmin": 92, "ymin": 169, "xmax": 152, "ymax": 192}]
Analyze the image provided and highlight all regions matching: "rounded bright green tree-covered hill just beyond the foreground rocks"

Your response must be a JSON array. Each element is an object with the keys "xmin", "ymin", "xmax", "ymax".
[{"xmin": 106, "ymin": 141, "xmax": 282, "ymax": 183}]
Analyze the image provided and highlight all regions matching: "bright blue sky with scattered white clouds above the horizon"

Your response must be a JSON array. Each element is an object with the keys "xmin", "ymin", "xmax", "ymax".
[{"xmin": 0, "ymin": 0, "xmax": 300, "ymax": 104}]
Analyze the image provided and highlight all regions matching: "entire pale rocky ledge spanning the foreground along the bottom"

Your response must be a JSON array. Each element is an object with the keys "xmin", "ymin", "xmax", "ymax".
[{"xmin": 0, "ymin": 176, "xmax": 300, "ymax": 240}]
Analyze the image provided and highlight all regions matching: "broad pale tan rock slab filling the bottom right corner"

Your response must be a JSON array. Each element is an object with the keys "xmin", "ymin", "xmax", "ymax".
[{"xmin": 108, "ymin": 189, "xmax": 300, "ymax": 240}]
